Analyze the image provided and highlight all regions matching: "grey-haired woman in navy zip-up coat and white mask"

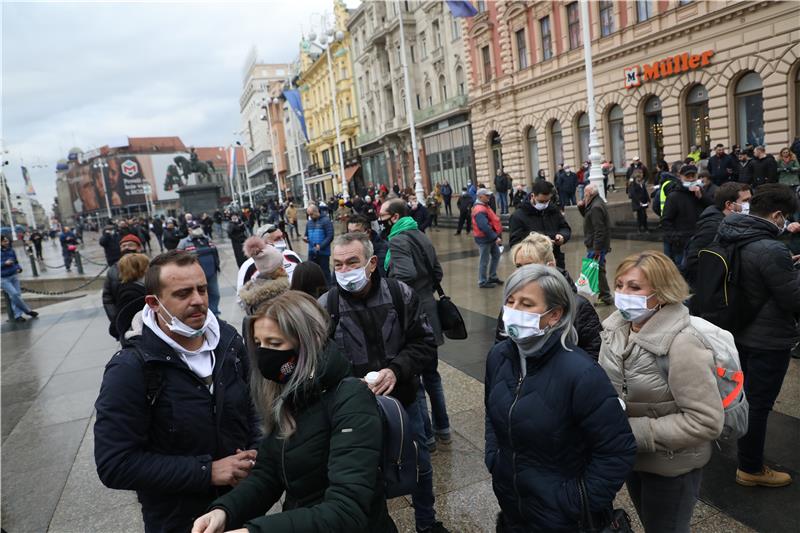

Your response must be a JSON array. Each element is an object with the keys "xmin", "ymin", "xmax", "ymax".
[{"xmin": 485, "ymin": 265, "xmax": 636, "ymax": 533}]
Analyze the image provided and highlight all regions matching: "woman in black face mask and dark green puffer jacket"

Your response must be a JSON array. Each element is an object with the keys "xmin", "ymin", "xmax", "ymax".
[{"xmin": 192, "ymin": 291, "xmax": 397, "ymax": 533}]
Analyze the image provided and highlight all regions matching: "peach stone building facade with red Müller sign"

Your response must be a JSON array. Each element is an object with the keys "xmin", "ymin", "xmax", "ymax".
[{"xmin": 464, "ymin": 0, "xmax": 800, "ymax": 184}]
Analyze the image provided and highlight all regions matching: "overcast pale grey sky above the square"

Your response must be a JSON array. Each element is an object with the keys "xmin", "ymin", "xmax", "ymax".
[{"xmin": 0, "ymin": 0, "xmax": 360, "ymax": 211}]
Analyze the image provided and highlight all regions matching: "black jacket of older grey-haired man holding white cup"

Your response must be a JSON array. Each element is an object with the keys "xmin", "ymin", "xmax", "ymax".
[{"xmin": 319, "ymin": 271, "xmax": 436, "ymax": 406}]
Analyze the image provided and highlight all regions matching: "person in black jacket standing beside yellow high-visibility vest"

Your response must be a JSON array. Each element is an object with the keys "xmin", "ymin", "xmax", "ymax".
[{"xmin": 661, "ymin": 165, "xmax": 712, "ymax": 267}]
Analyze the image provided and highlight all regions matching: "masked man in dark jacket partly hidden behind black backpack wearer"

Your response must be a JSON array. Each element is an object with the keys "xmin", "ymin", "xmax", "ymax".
[{"xmin": 681, "ymin": 181, "xmax": 753, "ymax": 288}]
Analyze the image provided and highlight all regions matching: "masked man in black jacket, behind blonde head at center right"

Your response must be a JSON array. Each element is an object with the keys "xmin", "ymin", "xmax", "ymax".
[{"xmin": 508, "ymin": 180, "xmax": 572, "ymax": 268}]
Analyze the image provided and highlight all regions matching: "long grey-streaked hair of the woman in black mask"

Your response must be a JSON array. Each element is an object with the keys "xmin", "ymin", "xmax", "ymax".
[{"xmin": 245, "ymin": 291, "xmax": 330, "ymax": 439}]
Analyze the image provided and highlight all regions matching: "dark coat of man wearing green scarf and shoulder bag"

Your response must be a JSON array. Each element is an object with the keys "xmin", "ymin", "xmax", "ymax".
[{"xmin": 386, "ymin": 229, "xmax": 444, "ymax": 346}]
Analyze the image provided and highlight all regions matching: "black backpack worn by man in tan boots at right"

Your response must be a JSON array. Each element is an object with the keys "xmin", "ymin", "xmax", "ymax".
[{"xmin": 689, "ymin": 236, "xmax": 763, "ymax": 333}]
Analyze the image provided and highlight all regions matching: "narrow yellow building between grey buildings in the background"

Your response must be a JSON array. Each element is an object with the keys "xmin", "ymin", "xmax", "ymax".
[{"xmin": 297, "ymin": 0, "xmax": 359, "ymax": 200}]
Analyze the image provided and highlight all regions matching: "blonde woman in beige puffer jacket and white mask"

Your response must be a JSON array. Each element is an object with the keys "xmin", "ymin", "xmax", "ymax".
[{"xmin": 599, "ymin": 251, "xmax": 724, "ymax": 533}]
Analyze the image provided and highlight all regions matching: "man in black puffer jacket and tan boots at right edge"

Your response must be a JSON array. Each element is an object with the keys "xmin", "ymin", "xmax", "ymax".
[{"xmin": 716, "ymin": 184, "xmax": 800, "ymax": 487}]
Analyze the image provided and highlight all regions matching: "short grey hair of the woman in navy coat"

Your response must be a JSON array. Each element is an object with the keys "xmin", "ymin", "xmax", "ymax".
[{"xmin": 503, "ymin": 264, "xmax": 578, "ymax": 350}]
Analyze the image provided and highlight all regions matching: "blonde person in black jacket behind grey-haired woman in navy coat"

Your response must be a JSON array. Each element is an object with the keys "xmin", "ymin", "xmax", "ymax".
[{"xmin": 495, "ymin": 232, "xmax": 601, "ymax": 360}]
